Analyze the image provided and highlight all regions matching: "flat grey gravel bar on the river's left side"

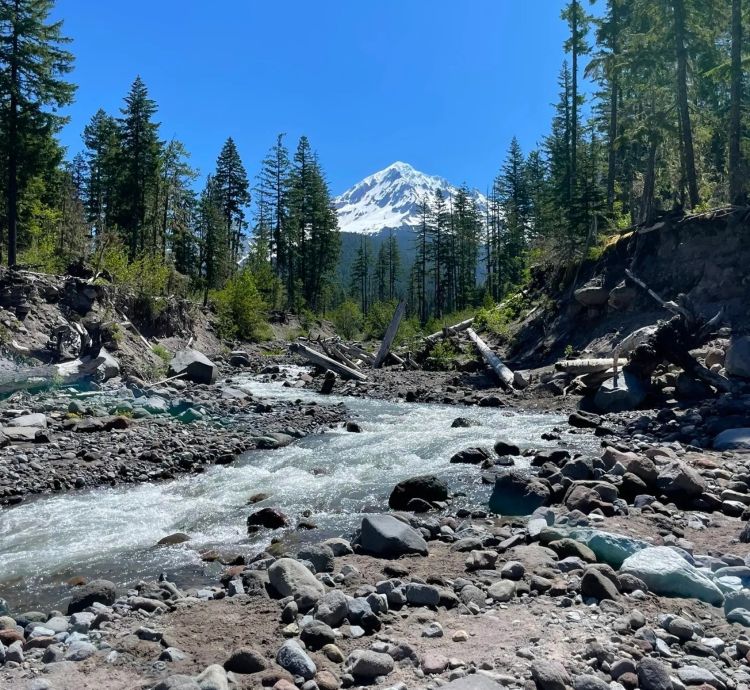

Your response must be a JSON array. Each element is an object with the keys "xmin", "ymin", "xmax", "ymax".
[{"xmin": 0, "ymin": 367, "xmax": 347, "ymax": 505}]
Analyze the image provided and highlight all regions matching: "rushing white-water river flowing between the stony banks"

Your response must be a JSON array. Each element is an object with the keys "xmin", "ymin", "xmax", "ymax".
[{"xmin": 0, "ymin": 368, "xmax": 584, "ymax": 606}]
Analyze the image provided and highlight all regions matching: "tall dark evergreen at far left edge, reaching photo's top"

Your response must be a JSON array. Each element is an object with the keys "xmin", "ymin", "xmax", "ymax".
[{"xmin": 0, "ymin": 0, "xmax": 75, "ymax": 266}]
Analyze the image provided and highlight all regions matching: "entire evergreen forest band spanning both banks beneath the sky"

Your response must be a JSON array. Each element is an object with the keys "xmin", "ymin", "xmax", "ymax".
[{"xmin": 0, "ymin": 0, "xmax": 750, "ymax": 336}]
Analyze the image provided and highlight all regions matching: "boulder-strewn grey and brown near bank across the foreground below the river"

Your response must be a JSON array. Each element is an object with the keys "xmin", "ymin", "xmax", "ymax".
[{"xmin": 0, "ymin": 354, "xmax": 750, "ymax": 690}]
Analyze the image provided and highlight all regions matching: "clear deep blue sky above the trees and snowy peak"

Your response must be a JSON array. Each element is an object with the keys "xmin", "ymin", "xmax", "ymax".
[{"xmin": 55, "ymin": 0, "xmax": 592, "ymax": 194}]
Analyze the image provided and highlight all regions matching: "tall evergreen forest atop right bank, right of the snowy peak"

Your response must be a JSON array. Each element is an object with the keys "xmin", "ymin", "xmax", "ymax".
[{"xmin": 351, "ymin": 0, "xmax": 750, "ymax": 330}]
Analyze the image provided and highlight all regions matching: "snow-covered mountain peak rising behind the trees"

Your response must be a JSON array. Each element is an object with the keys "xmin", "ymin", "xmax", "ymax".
[{"xmin": 334, "ymin": 161, "xmax": 487, "ymax": 235}]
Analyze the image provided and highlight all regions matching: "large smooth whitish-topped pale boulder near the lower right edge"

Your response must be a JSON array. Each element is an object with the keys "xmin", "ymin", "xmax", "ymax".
[{"xmin": 620, "ymin": 546, "xmax": 724, "ymax": 606}]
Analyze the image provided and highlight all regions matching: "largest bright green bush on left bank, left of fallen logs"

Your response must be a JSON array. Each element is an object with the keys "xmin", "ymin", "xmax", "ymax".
[{"xmin": 212, "ymin": 270, "xmax": 271, "ymax": 341}]
